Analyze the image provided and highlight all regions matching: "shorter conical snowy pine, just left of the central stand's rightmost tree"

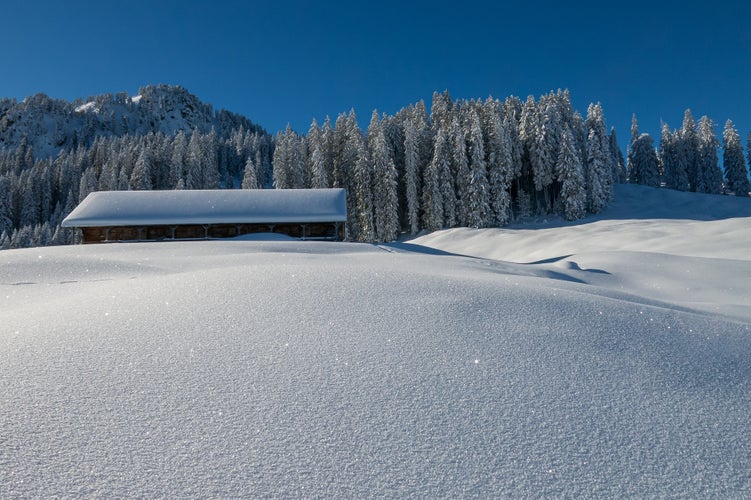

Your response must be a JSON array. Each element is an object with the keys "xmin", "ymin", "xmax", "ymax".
[{"xmin": 555, "ymin": 125, "xmax": 587, "ymax": 220}]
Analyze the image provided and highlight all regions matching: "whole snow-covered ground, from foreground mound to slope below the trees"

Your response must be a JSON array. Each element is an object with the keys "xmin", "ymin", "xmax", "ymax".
[{"xmin": 0, "ymin": 186, "xmax": 751, "ymax": 498}]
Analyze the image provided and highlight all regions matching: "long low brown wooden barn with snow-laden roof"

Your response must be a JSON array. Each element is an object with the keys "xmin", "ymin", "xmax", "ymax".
[{"xmin": 62, "ymin": 189, "xmax": 347, "ymax": 243}]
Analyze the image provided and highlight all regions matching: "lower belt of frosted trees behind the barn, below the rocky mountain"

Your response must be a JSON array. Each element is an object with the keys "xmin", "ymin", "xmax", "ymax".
[{"xmin": 0, "ymin": 125, "xmax": 273, "ymax": 248}]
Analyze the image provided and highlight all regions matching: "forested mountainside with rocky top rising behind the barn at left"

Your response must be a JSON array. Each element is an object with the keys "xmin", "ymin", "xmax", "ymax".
[{"xmin": 0, "ymin": 85, "xmax": 274, "ymax": 248}]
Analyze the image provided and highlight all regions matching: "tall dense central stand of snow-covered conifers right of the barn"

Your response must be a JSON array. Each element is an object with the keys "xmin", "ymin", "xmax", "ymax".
[{"xmin": 274, "ymin": 91, "xmax": 626, "ymax": 241}]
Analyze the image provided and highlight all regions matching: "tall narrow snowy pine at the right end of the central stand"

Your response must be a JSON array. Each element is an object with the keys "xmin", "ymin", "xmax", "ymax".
[{"xmin": 586, "ymin": 103, "xmax": 613, "ymax": 214}]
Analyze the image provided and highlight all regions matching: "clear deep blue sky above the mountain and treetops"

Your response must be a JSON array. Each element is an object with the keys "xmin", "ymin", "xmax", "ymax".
[{"xmin": 5, "ymin": 0, "xmax": 751, "ymax": 149}]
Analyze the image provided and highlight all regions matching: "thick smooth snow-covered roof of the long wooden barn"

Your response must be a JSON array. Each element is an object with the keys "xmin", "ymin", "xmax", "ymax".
[{"xmin": 62, "ymin": 189, "xmax": 347, "ymax": 227}]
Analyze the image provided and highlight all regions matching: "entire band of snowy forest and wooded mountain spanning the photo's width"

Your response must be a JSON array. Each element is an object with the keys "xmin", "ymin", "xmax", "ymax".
[{"xmin": 0, "ymin": 85, "xmax": 749, "ymax": 248}]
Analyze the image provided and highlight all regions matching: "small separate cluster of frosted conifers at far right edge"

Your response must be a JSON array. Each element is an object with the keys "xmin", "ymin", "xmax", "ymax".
[{"xmin": 628, "ymin": 109, "xmax": 751, "ymax": 196}]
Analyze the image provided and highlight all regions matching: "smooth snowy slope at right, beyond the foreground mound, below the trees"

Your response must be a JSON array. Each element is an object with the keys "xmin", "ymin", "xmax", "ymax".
[{"xmin": 410, "ymin": 185, "xmax": 751, "ymax": 321}]
